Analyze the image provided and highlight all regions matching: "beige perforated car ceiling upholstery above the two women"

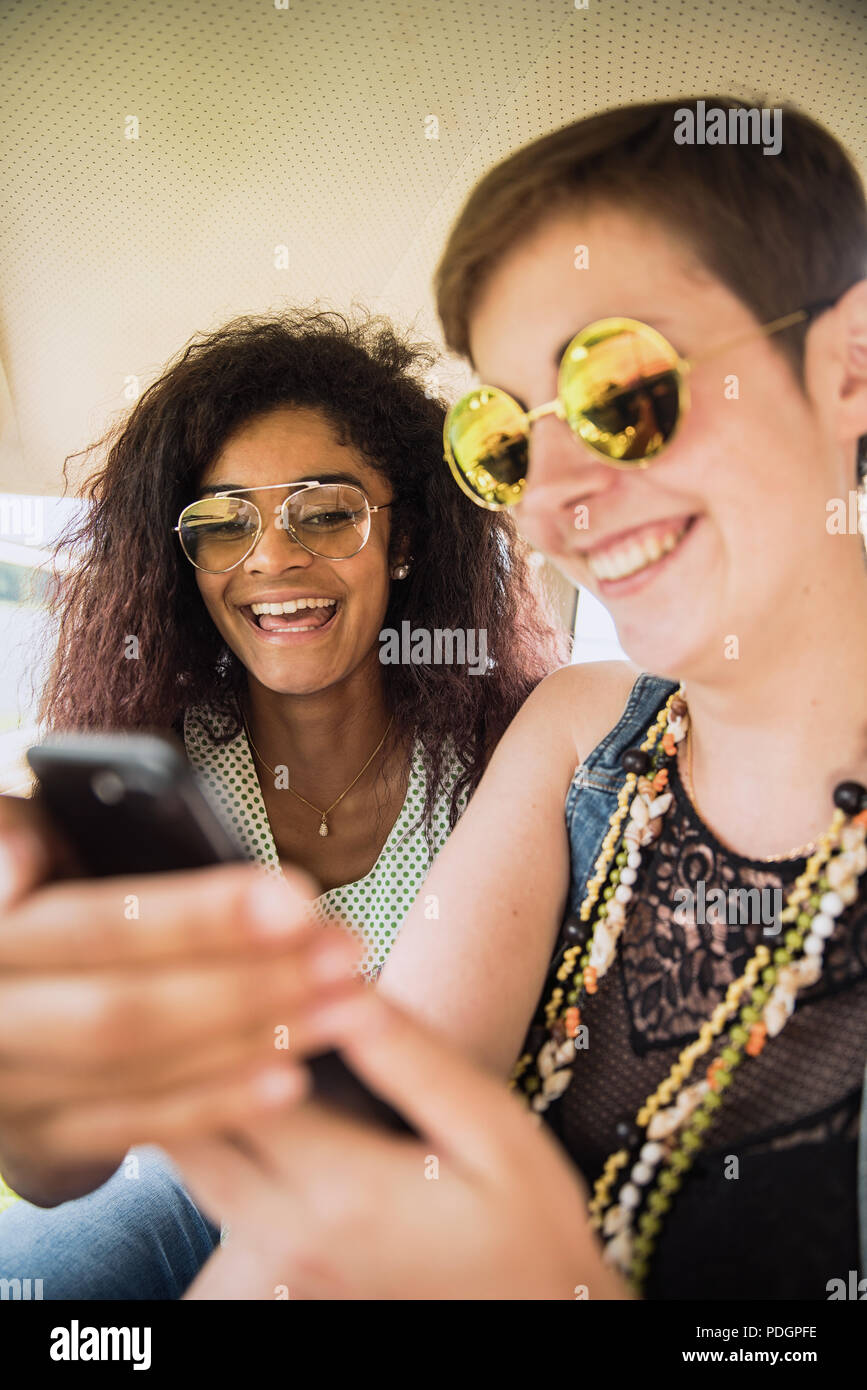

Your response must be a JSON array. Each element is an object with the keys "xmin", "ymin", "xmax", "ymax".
[{"xmin": 0, "ymin": 0, "xmax": 867, "ymax": 492}]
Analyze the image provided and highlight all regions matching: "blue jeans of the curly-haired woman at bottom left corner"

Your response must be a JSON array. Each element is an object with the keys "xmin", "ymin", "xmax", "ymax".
[{"xmin": 0, "ymin": 1148, "xmax": 220, "ymax": 1300}]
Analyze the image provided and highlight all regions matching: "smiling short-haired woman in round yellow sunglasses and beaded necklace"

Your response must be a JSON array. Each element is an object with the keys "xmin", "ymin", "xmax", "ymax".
[{"xmin": 169, "ymin": 97, "xmax": 867, "ymax": 1300}]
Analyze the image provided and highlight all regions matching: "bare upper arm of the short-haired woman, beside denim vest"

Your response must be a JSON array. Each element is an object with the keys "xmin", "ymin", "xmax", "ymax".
[{"xmin": 379, "ymin": 662, "xmax": 638, "ymax": 1074}]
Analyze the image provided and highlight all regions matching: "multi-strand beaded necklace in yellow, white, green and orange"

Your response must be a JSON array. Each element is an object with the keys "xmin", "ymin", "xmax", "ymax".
[{"xmin": 511, "ymin": 687, "xmax": 867, "ymax": 1293}]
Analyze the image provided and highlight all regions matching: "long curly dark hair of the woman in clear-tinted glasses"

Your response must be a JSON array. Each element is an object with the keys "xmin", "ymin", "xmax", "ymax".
[{"xmin": 40, "ymin": 306, "xmax": 567, "ymax": 835}]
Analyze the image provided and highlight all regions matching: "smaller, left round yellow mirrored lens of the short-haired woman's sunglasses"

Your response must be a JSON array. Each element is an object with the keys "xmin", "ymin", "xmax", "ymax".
[{"xmin": 443, "ymin": 386, "xmax": 528, "ymax": 512}]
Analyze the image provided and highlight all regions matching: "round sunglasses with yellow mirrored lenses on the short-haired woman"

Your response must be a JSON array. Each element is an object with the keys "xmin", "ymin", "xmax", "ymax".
[{"xmin": 443, "ymin": 299, "xmax": 836, "ymax": 512}]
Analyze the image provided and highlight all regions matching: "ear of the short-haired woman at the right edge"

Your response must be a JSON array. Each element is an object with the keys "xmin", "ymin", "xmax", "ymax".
[{"xmin": 804, "ymin": 279, "xmax": 867, "ymax": 445}]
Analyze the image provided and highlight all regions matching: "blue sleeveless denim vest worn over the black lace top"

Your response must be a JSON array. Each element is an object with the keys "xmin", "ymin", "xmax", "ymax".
[{"xmin": 566, "ymin": 676, "xmax": 867, "ymax": 1273}]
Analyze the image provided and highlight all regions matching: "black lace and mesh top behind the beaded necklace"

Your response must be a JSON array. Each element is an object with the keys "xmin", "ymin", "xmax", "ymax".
[{"xmin": 547, "ymin": 767, "xmax": 867, "ymax": 1298}]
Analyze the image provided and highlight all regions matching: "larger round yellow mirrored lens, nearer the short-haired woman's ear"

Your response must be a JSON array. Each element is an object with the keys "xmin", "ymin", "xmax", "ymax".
[{"xmin": 560, "ymin": 318, "xmax": 685, "ymax": 463}]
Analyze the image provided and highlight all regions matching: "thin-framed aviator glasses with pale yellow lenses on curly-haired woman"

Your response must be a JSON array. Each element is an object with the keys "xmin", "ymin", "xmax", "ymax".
[{"xmin": 175, "ymin": 480, "xmax": 392, "ymax": 574}]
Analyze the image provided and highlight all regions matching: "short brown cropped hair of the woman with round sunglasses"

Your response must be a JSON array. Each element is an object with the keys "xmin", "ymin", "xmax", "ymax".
[{"xmin": 435, "ymin": 96, "xmax": 867, "ymax": 403}]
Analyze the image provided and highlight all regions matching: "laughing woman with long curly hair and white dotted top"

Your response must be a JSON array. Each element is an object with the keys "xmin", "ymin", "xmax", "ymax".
[{"xmin": 0, "ymin": 310, "xmax": 567, "ymax": 1297}]
